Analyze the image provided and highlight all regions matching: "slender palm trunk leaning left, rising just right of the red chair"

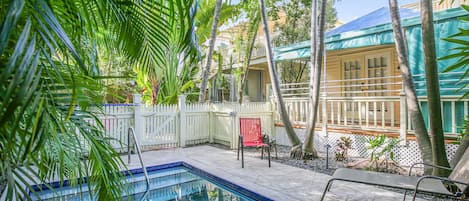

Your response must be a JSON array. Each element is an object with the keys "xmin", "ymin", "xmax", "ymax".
[{"xmin": 259, "ymin": 0, "xmax": 302, "ymax": 158}]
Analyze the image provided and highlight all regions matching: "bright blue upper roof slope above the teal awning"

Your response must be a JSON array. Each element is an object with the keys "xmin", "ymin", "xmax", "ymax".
[{"xmin": 326, "ymin": 7, "xmax": 419, "ymax": 36}]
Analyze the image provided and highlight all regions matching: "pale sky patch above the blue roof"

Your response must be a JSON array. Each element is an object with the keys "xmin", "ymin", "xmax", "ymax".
[{"xmin": 335, "ymin": 0, "xmax": 418, "ymax": 23}]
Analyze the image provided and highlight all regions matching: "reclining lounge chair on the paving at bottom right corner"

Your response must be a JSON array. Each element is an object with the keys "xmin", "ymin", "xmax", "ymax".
[{"xmin": 321, "ymin": 149, "xmax": 469, "ymax": 201}]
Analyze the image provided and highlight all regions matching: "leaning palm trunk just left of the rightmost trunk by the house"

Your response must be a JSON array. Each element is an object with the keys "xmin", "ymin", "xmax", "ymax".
[{"xmin": 389, "ymin": 0, "xmax": 433, "ymax": 174}]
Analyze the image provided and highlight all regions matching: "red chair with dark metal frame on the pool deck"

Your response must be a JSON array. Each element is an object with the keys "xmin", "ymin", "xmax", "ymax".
[{"xmin": 238, "ymin": 118, "xmax": 270, "ymax": 168}]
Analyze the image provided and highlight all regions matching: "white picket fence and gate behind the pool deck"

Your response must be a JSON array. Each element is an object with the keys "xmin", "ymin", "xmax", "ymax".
[{"xmin": 94, "ymin": 96, "xmax": 275, "ymax": 152}]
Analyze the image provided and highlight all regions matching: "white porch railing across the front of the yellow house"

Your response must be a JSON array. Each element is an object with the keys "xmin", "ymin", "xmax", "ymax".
[{"xmin": 271, "ymin": 73, "xmax": 469, "ymax": 140}]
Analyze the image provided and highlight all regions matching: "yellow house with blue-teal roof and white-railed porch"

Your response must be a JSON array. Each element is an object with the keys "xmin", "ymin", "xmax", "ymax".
[{"xmin": 275, "ymin": 5, "xmax": 469, "ymax": 138}]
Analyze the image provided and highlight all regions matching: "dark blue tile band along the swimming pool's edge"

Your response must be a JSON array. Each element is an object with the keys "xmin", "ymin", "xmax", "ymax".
[{"xmin": 27, "ymin": 161, "xmax": 273, "ymax": 201}]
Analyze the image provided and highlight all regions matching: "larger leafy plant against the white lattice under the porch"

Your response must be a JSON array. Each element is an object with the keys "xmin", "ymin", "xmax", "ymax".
[{"xmin": 367, "ymin": 134, "xmax": 400, "ymax": 170}]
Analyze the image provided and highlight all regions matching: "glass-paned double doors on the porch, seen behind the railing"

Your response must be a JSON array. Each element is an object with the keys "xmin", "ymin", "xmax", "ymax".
[{"xmin": 337, "ymin": 53, "xmax": 392, "ymax": 125}]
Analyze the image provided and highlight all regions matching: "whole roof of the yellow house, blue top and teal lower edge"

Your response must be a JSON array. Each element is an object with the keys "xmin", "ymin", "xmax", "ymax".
[{"xmin": 274, "ymin": 8, "xmax": 468, "ymax": 61}]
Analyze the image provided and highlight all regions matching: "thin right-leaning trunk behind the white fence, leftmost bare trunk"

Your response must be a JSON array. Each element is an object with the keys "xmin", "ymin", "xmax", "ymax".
[{"xmin": 199, "ymin": 0, "xmax": 222, "ymax": 103}]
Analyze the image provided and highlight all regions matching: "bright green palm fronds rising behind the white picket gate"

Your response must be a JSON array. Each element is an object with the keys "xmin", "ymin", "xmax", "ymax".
[{"xmin": 128, "ymin": 0, "xmax": 200, "ymax": 104}]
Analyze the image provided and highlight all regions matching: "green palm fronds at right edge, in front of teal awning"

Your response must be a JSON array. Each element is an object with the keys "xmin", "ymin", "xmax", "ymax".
[{"xmin": 439, "ymin": 4, "xmax": 469, "ymax": 97}]
